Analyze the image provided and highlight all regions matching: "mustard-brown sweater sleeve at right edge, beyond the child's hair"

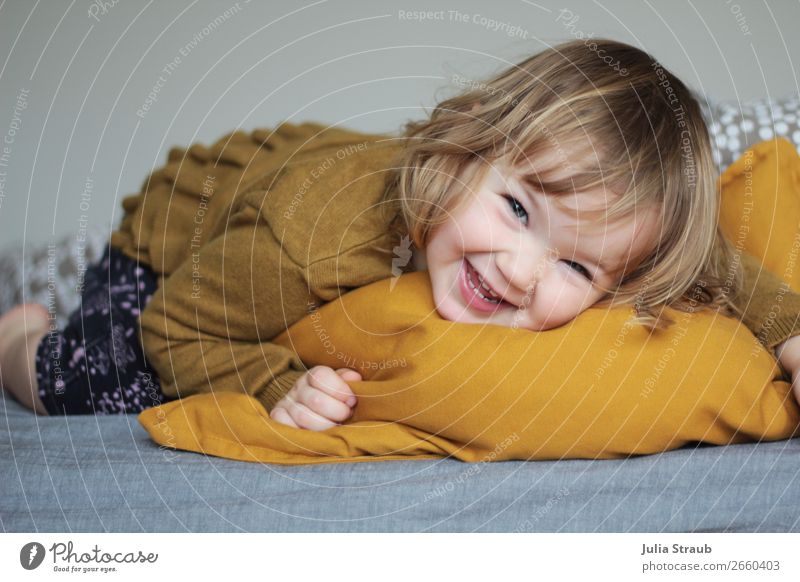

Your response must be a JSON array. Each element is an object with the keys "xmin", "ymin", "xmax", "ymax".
[{"xmin": 734, "ymin": 253, "xmax": 800, "ymax": 377}]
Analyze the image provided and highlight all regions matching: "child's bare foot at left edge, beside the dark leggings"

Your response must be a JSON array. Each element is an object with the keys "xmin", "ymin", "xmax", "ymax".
[{"xmin": 0, "ymin": 303, "xmax": 49, "ymax": 415}]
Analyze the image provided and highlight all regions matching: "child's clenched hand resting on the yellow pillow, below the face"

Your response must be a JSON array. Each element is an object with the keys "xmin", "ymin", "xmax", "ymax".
[{"xmin": 269, "ymin": 366, "xmax": 361, "ymax": 430}]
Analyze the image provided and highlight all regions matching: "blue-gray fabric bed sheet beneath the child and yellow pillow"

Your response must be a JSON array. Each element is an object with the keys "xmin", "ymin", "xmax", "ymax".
[{"xmin": 0, "ymin": 392, "xmax": 800, "ymax": 532}]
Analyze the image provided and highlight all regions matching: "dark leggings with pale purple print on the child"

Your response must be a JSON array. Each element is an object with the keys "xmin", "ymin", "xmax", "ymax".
[{"xmin": 36, "ymin": 246, "xmax": 168, "ymax": 416}]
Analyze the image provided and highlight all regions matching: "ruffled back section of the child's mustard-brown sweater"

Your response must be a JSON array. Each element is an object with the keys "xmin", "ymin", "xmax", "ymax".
[{"xmin": 111, "ymin": 122, "xmax": 352, "ymax": 276}]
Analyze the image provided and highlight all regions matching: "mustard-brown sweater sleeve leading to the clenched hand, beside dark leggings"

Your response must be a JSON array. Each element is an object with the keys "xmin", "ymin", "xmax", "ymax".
[{"xmin": 141, "ymin": 194, "xmax": 313, "ymax": 410}]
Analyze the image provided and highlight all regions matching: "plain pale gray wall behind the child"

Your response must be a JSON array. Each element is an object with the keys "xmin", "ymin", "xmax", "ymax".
[{"xmin": 0, "ymin": 0, "xmax": 800, "ymax": 248}]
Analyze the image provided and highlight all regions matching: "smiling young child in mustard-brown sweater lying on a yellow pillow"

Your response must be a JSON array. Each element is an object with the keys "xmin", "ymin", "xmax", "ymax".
[{"xmin": 0, "ymin": 40, "xmax": 800, "ymax": 430}]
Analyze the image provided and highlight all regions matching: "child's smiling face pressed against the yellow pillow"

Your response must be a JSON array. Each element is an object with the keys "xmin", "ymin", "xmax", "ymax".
[{"xmin": 424, "ymin": 152, "xmax": 658, "ymax": 331}]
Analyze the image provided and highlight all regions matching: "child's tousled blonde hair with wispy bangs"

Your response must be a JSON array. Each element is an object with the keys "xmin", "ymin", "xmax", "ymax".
[{"xmin": 386, "ymin": 39, "xmax": 742, "ymax": 331}]
